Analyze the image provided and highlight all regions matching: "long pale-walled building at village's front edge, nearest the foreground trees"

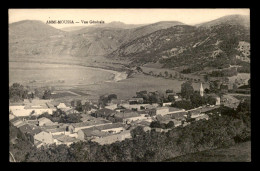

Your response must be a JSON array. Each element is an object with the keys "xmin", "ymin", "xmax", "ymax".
[{"xmin": 92, "ymin": 130, "xmax": 132, "ymax": 145}]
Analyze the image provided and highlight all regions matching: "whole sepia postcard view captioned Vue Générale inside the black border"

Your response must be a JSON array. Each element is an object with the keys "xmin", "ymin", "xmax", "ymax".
[{"xmin": 8, "ymin": 8, "xmax": 251, "ymax": 163}]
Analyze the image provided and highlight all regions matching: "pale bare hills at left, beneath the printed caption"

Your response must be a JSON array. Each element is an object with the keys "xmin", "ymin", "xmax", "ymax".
[{"xmin": 9, "ymin": 20, "xmax": 185, "ymax": 57}]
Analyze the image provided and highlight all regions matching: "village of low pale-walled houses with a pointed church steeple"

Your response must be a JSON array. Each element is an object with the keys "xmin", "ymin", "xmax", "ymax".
[{"xmin": 9, "ymin": 80, "xmax": 247, "ymax": 148}]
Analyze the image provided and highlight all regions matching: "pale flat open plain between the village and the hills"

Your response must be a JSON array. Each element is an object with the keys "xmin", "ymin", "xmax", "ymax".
[{"xmin": 9, "ymin": 57, "xmax": 208, "ymax": 101}]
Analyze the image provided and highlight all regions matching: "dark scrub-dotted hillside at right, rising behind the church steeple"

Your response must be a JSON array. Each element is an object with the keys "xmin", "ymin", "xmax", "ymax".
[{"xmin": 108, "ymin": 14, "xmax": 250, "ymax": 72}]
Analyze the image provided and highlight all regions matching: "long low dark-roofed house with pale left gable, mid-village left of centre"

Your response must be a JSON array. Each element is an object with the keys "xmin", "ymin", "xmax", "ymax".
[{"xmin": 68, "ymin": 118, "xmax": 112, "ymax": 134}]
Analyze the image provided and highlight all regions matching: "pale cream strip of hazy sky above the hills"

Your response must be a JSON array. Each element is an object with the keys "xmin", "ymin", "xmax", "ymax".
[{"xmin": 9, "ymin": 8, "xmax": 250, "ymax": 28}]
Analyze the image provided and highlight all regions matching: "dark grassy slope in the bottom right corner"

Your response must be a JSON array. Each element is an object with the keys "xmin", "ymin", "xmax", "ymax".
[{"xmin": 167, "ymin": 141, "xmax": 251, "ymax": 162}]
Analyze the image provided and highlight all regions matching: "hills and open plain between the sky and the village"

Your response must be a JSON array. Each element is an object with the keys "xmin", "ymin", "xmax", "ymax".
[{"xmin": 9, "ymin": 15, "xmax": 250, "ymax": 101}]
